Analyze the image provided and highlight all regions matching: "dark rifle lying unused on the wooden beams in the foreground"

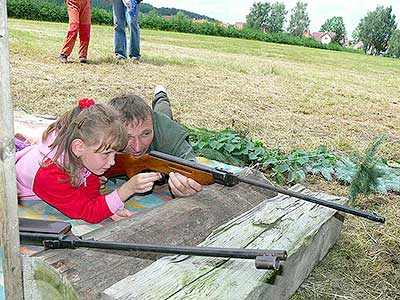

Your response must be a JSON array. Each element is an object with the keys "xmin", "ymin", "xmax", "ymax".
[{"xmin": 19, "ymin": 219, "xmax": 287, "ymax": 270}]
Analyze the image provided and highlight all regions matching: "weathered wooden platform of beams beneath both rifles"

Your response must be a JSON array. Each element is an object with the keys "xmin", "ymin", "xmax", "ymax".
[{"xmin": 23, "ymin": 172, "xmax": 345, "ymax": 300}]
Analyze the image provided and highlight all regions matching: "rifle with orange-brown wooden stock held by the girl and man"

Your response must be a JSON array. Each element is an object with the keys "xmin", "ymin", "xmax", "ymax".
[{"xmin": 105, "ymin": 151, "xmax": 385, "ymax": 223}]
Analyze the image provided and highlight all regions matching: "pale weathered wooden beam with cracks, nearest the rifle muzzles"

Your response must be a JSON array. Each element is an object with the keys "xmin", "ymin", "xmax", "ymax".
[{"xmin": 104, "ymin": 186, "xmax": 345, "ymax": 300}]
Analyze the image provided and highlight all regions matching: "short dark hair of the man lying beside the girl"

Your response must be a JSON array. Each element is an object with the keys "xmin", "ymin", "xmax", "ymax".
[{"xmin": 110, "ymin": 94, "xmax": 152, "ymax": 125}]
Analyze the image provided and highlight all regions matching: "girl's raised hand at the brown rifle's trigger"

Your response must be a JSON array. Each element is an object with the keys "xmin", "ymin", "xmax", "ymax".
[{"xmin": 117, "ymin": 172, "xmax": 161, "ymax": 201}]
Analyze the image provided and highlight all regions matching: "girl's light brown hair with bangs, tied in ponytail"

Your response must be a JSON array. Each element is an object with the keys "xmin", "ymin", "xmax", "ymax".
[{"xmin": 42, "ymin": 104, "xmax": 128, "ymax": 187}]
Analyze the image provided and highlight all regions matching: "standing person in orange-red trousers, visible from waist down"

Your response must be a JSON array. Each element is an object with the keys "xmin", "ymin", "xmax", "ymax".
[{"xmin": 59, "ymin": 0, "xmax": 90, "ymax": 63}]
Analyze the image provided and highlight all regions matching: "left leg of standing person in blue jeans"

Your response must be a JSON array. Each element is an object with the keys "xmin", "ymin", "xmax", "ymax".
[{"xmin": 113, "ymin": 0, "xmax": 127, "ymax": 59}]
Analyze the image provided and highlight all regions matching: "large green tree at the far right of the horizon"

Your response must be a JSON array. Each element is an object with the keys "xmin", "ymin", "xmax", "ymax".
[{"xmin": 353, "ymin": 6, "xmax": 397, "ymax": 55}]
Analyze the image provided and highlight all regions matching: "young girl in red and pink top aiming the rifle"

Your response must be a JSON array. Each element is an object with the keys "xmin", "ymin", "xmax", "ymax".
[{"xmin": 16, "ymin": 99, "xmax": 161, "ymax": 223}]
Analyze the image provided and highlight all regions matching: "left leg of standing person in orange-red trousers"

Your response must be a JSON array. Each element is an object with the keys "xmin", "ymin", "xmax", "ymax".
[{"xmin": 60, "ymin": 0, "xmax": 80, "ymax": 62}]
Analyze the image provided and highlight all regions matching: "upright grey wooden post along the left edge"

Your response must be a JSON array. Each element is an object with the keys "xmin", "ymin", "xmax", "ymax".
[{"xmin": 0, "ymin": 0, "xmax": 23, "ymax": 299}]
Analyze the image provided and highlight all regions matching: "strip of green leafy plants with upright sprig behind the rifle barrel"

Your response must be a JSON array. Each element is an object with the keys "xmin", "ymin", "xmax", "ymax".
[{"xmin": 187, "ymin": 128, "xmax": 400, "ymax": 199}]
